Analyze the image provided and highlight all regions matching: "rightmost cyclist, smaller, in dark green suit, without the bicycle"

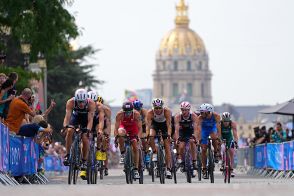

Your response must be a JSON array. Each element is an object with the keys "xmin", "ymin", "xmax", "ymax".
[{"xmin": 221, "ymin": 112, "xmax": 238, "ymax": 177}]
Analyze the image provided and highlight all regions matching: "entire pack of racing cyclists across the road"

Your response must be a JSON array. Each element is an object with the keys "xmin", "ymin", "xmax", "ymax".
[{"xmin": 63, "ymin": 89, "xmax": 238, "ymax": 179}]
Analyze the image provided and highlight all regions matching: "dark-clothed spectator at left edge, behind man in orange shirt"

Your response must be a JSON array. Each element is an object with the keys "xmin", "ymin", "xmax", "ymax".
[{"xmin": 0, "ymin": 79, "xmax": 14, "ymax": 121}]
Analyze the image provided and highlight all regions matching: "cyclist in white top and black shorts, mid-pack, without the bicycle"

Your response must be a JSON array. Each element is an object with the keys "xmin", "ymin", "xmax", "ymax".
[{"xmin": 146, "ymin": 98, "xmax": 172, "ymax": 179}]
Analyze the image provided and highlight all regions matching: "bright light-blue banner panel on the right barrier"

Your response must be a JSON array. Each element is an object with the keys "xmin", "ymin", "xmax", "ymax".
[{"xmin": 267, "ymin": 143, "xmax": 284, "ymax": 170}]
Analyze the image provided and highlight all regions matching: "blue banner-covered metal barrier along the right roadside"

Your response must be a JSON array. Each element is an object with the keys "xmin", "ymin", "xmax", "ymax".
[{"xmin": 237, "ymin": 141, "xmax": 294, "ymax": 179}]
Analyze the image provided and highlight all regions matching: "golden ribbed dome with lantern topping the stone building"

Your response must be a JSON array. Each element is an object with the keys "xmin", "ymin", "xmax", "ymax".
[{"xmin": 159, "ymin": 0, "xmax": 205, "ymax": 56}]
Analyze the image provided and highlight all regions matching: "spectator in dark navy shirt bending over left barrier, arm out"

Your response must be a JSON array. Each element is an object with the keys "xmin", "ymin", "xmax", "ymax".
[{"xmin": 17, "ymin": 120, "xmax": 51, "ymax": 137}]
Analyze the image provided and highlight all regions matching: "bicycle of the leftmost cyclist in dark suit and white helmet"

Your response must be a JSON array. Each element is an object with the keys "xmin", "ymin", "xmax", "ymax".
[{"xmin": 65, "ymin": 126, "xmax": 82, "ymax": 184}]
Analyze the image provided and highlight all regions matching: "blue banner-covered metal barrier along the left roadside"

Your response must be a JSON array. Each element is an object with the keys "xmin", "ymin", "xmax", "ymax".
[{"xmin": 0, "ymin": 123, "xmax": 45, "ymax": 185}]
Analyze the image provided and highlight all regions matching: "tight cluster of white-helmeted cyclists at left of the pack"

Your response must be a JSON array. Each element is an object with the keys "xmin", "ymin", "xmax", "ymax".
[{"xmin": 63, "ymin": 89, "xmax": 111, "ymax": 180}]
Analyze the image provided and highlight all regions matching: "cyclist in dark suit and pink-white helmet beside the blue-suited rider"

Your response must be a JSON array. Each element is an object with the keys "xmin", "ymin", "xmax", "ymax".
[{"xmin": 175, "ymin": 101, "xmax": 198, "ymax": 169}]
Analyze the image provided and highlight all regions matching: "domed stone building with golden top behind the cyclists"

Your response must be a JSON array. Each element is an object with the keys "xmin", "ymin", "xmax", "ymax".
[{"xmin": 153, "ymin": 0, "xmax": 212, "ymax": 108}]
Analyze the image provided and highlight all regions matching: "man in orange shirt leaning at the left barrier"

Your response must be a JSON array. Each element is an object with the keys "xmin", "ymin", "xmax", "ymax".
[{"xmin": 5, "ymin": 88, "xmax": 35, "ymax": 134}]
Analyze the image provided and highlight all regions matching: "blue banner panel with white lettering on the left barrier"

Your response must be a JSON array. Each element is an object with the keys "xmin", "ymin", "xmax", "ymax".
[{"xmin": 9, "ymin": 136, "xmax": 23, "ymax": 176}]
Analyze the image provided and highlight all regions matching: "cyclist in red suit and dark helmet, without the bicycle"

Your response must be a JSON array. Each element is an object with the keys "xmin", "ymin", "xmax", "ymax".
[{"xmin": 114, "ymin": 101, "xmax": 142, "ymax": 179}]
